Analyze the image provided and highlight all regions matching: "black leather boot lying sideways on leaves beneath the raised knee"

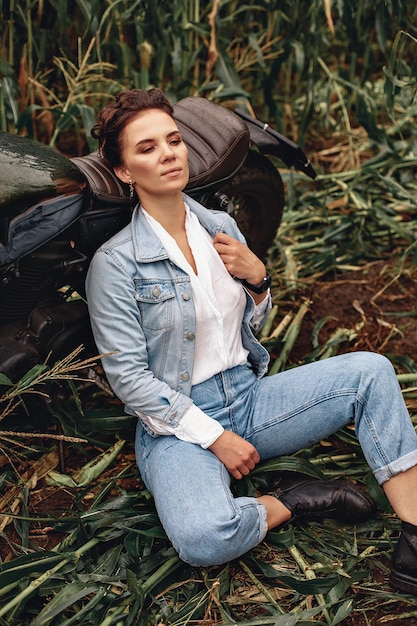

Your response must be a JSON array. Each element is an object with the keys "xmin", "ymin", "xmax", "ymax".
[{"xmin": 268, "ymin": 472, "xmax": 376, "ymax": 524}]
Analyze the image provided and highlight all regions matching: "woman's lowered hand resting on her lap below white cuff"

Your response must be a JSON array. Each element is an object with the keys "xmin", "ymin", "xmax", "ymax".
[{"xmin": 209, "ymin": 430, "xmax": 260, "ymax": 480}]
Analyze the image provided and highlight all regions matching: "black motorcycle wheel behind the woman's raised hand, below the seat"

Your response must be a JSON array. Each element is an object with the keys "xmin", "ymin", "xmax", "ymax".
[{"xmin": 220, "ymin": 150, "xmax": 285, "ymax": 259}]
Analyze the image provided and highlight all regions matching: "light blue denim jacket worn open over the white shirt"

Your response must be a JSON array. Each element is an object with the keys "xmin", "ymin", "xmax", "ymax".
[{"xmin": 86, "ymin": 195, "xmax": 269, "ymax": 427}]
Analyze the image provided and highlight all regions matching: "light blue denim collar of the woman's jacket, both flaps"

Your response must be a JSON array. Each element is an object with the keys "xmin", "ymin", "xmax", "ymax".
[{"xmin": 131, "ymin": 194, "xmax": 226, "ymax": 263}]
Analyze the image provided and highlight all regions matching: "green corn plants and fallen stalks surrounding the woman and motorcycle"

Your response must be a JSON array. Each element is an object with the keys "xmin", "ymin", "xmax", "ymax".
[{"xmin": 0, "ymin": 0, "xmax": 417, "ymax": 626}]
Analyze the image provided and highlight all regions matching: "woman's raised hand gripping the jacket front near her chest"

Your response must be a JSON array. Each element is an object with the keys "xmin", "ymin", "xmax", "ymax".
[{"xmin": 213, "ymin": 233, "xmax": 266, "ymax": 285}]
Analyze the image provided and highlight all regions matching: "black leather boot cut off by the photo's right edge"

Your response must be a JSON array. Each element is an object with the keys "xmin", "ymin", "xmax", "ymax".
[{"xmin": 390, "ymin": 522, "xmax": 417, "ymax": 595}]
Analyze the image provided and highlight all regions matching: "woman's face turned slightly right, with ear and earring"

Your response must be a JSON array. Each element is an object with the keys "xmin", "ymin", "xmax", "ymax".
[{"xmin": 115, "ymin": 109, "xmax": 189, "ymax": 203}]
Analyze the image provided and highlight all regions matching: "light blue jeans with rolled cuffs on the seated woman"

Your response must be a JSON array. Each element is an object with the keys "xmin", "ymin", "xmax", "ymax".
[{"xmin": 136, "ymin": 352, "xmax": 417, "ymax": 566}]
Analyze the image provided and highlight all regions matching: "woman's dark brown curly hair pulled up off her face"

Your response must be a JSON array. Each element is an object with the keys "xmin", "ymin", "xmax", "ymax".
[{"xmin": 91, "ymin": 89, "xmax": 173, "ymax": 167}]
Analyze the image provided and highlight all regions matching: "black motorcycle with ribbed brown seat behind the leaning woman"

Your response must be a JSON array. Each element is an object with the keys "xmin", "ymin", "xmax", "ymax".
[{"xmin": 0, "ymin": 97, "xmax": 315, "ymax": 381}]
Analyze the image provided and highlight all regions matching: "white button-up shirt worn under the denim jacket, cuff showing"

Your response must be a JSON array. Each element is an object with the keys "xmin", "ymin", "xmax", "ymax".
[{"xmin": 141, "ymin": 205, "xmax": 268, "ymax": 448}]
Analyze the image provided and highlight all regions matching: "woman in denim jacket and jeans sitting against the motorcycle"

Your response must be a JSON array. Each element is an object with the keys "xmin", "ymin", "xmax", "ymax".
[{"xmin": 87, "ymin": 89, "xmax": 417, "ymax": 593}]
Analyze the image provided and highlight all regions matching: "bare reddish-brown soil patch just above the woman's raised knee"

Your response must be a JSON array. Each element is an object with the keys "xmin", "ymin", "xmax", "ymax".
[{"xmin": 284, "ymin": 260, "xmax": 417, "ymax": 371}]
